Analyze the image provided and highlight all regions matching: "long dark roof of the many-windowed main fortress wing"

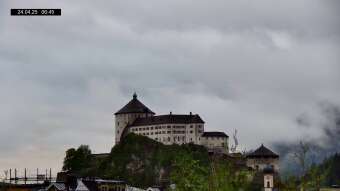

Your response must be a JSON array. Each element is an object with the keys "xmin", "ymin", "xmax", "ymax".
[{"xmin": 130, "ymin": 114, "xmax": 204, "ymax": 127}]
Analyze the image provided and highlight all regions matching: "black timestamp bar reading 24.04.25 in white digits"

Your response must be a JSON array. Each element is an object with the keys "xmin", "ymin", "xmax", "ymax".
[{"xmin": 11, "ymin": 9, "xmax": 61, "ymax": 16}]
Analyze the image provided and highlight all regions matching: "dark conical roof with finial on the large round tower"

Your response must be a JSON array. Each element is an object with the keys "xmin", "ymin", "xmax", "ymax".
[{"xmin": 115, "ymin": 93, "xmax": 155, "ymax": 115}]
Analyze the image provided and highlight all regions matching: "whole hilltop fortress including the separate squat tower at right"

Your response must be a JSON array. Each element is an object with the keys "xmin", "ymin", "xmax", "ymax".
[{"xmin": 115, "ymin": 93, "xmax": 279, "ymax": 177}]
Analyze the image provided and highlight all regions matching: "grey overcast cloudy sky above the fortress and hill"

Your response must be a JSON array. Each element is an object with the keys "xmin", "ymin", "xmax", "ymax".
[{"xmin": 0, "ymin": 0, "xmax": 340, "ymax": 174}]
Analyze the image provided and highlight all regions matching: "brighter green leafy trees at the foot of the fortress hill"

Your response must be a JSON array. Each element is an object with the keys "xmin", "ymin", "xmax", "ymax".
[{"xmin": 171, "ymin": 153, "xmax": 252, "ymax": 191}]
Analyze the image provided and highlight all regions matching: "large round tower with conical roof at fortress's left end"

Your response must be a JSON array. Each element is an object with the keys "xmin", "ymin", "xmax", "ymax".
[{"xmin": 115, "ymin": 92, "xmax": 155, "ymax": 144}]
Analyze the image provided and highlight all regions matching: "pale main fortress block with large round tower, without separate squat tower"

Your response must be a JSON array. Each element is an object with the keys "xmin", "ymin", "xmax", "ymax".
[{"xmin": 115, "ymin": 94, "xmax": 228, "ymax": 153}]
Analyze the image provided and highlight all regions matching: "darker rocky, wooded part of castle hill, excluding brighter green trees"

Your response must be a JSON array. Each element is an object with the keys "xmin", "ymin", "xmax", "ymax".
[{"xmin": 63, "ymin": 134, "xmax": 209, "ymax": 187}]
